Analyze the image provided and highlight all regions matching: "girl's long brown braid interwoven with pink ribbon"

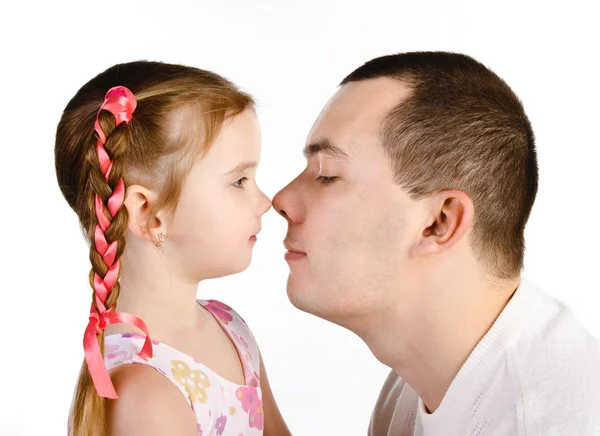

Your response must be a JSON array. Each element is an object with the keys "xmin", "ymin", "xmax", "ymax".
[{"xmin": 72, "ymin": 87, "xmax": 152, "ymax": 436}]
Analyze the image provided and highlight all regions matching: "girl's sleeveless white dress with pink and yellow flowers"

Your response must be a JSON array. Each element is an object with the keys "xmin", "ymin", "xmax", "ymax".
[{"xmin": 71, "ymin": 300, "xmax": 263, "ymax": 436}]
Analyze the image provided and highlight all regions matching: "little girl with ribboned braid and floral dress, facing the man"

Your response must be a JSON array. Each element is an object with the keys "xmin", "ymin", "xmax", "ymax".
[{"xmin": 55, "ymin": 62, "xmax": 290, "ymax": 436}]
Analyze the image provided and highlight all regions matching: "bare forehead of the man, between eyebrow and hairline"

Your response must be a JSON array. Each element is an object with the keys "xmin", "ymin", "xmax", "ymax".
[{"xmin": 307, "ymin": 78, "xmax": 410, "ymax": 151}]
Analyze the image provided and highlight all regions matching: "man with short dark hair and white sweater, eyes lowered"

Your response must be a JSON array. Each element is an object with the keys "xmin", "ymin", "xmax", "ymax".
[{"xmin": 273, "ymin": 53, "xmax": 600, "ymax": 436}]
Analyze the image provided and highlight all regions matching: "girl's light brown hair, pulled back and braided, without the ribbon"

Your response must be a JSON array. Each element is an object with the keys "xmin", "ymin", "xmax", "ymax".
[{"xmin": 55, "ymin": 61, "xmax": 254, "ymax": 436}]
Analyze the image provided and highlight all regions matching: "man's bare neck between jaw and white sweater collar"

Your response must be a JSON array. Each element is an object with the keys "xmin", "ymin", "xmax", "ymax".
[{"xmin": 352, "ymin": 275, "xmax": 519, "ymax": 413}]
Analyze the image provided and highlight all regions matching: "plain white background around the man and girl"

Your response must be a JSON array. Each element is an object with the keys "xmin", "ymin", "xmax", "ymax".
[{"xmin": 0, "ymin": 0, "xmax": 600, "ymax": 436}]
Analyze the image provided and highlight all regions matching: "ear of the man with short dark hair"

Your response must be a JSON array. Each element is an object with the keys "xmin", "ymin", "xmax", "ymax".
[{"xmin": 413, "ymin": 190, "xmax": 475, "ymax": 254}]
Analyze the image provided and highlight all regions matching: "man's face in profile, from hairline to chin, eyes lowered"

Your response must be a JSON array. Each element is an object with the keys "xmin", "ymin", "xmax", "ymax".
[{"xmin": 273, "ymin": 78, "xmax": 420, "ymax": 322}]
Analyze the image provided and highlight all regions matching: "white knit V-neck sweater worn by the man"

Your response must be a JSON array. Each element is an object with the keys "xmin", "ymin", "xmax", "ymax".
[{"xmin": 369, "ymin": 279, "xmax": 600, "ymax": 436}]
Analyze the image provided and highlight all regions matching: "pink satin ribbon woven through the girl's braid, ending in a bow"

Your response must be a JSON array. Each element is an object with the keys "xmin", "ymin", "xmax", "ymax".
[{"xmin": 83, "ymin": 86, "xmax": 152, "ymax": 399}]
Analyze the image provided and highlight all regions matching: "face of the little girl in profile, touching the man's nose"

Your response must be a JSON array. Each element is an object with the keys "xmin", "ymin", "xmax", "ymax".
[{"xmin": 163, "ymin": 109, "xmax": 271, "ymax": 283}]
